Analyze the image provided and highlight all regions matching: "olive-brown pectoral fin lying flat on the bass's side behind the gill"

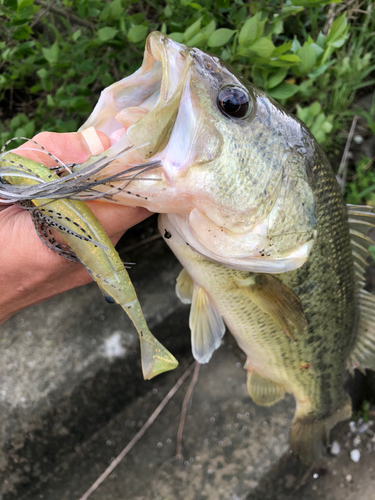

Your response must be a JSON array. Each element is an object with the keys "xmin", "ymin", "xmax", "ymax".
[{"xmin": 237, "ymin": 274, "xmax": 306, "ymax": 340}]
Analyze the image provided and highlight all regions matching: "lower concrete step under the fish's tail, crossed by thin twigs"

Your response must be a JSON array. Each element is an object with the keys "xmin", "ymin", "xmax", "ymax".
[{"xmin": 20, "ymin": 343, "xmax": 294, "ymax": 500}]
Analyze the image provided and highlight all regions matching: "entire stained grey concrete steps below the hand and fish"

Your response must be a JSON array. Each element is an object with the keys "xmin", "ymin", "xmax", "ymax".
[{"xmin": 0, "ymin": 216, "xmax": 375, "ymax": 500}]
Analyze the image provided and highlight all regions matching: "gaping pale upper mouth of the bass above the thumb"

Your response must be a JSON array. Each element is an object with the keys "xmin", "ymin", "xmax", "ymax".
[{"xmin": 80, "ymin": 32, "xmax": 193, "ymax": 159}]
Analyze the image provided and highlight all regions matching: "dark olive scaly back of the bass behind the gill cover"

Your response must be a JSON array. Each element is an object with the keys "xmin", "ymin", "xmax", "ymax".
[{"xmin": 278, "ymin": 146, "xmax": 358, "ymax": 418}]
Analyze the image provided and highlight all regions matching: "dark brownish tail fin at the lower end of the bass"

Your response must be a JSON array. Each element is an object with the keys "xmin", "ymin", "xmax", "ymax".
[{"xmin": 289, "ymin": 395, "xmax": 352, "ymax": 464}]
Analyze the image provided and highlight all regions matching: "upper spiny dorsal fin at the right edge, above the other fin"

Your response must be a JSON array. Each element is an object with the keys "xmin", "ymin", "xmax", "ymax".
[{"xmin": 347, "ymin": 205, "xmax": 375, "ymax": 289}]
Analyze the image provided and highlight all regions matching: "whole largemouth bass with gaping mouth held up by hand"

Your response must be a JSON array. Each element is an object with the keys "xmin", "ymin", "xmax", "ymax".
[{"xmin": 2, "ymin": 33, "xmax": 375, "ymax": 462}]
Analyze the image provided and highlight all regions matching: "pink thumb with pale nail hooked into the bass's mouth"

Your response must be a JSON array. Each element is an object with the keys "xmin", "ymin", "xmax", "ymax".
[{"xmin": 15, "ymin": 127, "xmax": 110, "ymax": 167}]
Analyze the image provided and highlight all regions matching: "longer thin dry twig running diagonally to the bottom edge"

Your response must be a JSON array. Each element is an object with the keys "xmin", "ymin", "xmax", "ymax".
[{"xmin": 80, "ymin": 363, "xmax": 195, "ymax": 500}]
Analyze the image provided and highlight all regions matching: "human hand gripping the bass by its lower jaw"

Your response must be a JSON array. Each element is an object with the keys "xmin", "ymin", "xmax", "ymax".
[{"xmin": 0, "ymin": 132, "xmax": 151, "ymax": 324}]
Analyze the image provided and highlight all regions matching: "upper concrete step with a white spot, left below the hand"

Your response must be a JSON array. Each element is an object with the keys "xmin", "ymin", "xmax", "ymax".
[{"xmin": 0, "ymin": 235, "xmax": 189, "ymax": 500}]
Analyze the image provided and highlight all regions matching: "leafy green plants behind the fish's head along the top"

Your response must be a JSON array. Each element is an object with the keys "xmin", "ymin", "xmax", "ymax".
[{"xmin": 0, "ymin": 0, "xmax": 375, "ymax": 176}]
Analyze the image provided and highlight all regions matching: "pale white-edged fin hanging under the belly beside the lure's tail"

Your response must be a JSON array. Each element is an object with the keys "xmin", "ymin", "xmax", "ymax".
[{"xmin": 189, "ymin": 285, "xmax": 225, "ymax": 363}]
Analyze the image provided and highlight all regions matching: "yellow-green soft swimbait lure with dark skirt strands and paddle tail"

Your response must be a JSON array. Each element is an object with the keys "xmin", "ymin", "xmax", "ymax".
[{"xmin": 0, "ymin": 144, "xmax": 178, "ymax": 379}]
